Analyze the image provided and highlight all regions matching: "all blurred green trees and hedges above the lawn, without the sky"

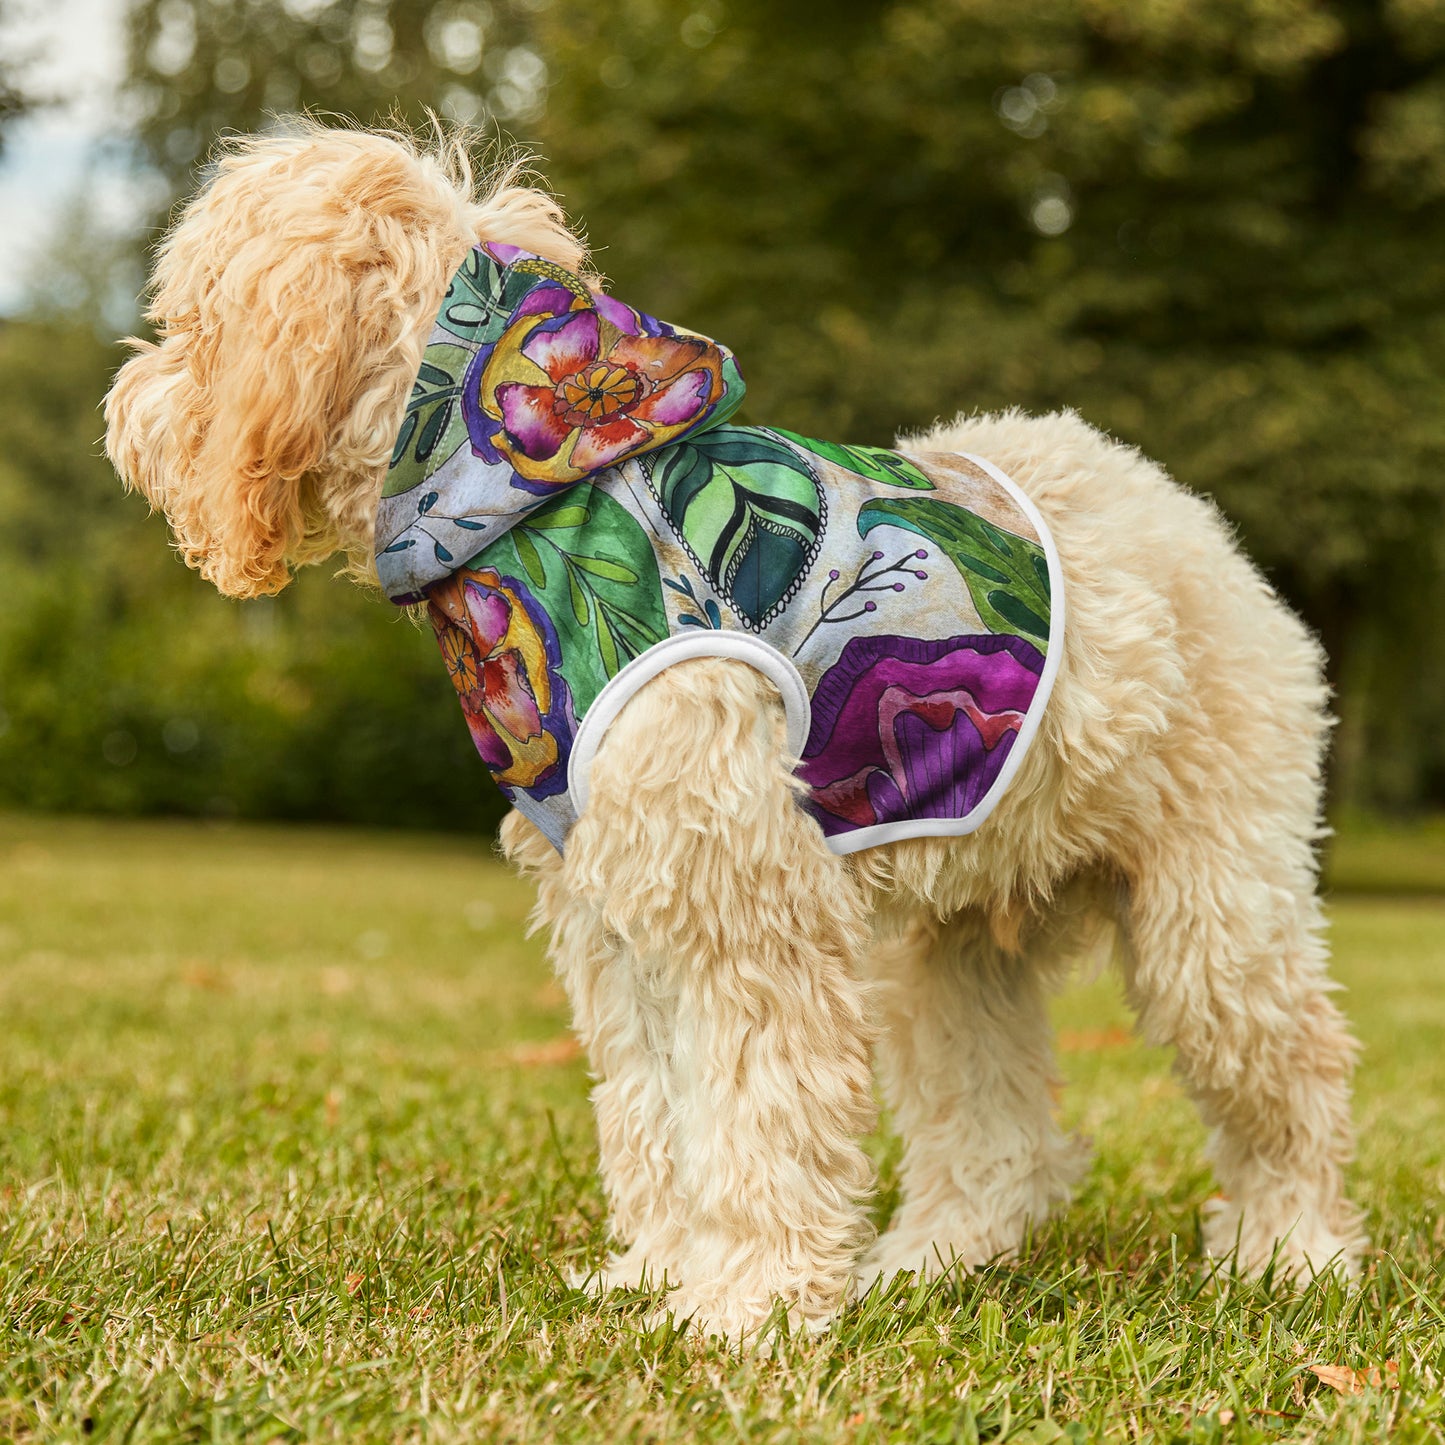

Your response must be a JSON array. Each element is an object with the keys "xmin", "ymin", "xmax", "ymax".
[{"xmin": 0, "ymin": 0, "xmax": 1445, "ymax": 827}]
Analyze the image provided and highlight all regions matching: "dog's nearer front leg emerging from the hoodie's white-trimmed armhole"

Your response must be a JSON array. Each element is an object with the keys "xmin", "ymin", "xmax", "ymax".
[{"xmin": 564, "ymin": 659, "xmax": 874, "ymax": 1340}]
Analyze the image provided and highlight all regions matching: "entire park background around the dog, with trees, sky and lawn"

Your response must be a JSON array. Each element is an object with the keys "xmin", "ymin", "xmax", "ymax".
[{"xmin": 0, "ymin": 0, "xmax": 1445, "ymax": 1445}]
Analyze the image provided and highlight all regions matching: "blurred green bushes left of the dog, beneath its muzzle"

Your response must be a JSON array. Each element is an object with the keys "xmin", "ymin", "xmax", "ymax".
[{"xmin": 0, "ymin": 315, "xmax": 501, "ymax": 831}]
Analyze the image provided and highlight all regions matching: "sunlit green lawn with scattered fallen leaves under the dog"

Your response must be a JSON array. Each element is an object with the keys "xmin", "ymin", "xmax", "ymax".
[{"xmin": 0, "ymin": 818, "xmax": 1445, "ymax": 1445}]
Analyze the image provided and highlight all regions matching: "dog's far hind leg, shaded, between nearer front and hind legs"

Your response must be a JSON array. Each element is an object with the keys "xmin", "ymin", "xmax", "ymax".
[{"xmin": 860, "ymin": 912, "xmax": 1088, "ymax": 1287}]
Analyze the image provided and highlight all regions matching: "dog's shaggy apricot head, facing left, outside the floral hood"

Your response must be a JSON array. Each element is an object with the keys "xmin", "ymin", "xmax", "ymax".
[{"xmin": 105, "ymin": 123, "xmax": 584, "ymax": 597}]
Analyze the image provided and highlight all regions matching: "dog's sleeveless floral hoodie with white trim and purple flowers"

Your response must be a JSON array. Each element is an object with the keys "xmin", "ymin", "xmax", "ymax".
[{"xmin": 377, "ymin": 243, "xmax": 1064, "ymax": 853}]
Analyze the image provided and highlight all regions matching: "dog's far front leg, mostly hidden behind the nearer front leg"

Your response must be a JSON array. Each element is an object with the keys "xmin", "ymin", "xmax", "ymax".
[{"xmin": 501, "ymin": 812, "xmax": 688, "ymax": 1293}]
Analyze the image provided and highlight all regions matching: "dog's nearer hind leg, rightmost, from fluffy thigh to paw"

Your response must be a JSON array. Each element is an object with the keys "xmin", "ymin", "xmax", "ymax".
[{"xmin": 1092, "ymin": 572, "xmax": 1364, "ymax": 1273}]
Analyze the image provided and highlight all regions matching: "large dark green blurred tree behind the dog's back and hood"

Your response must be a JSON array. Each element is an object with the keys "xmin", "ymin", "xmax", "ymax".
[{"xmin": 538, "ymin": 0, "xmax": 1445, "ymax": 802}]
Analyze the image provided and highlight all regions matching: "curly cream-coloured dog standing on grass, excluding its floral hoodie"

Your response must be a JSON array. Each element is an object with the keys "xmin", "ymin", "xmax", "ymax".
[{"xmin": 107, "ymin": 127, "xmax": 1363, "ymax": 1338}]
